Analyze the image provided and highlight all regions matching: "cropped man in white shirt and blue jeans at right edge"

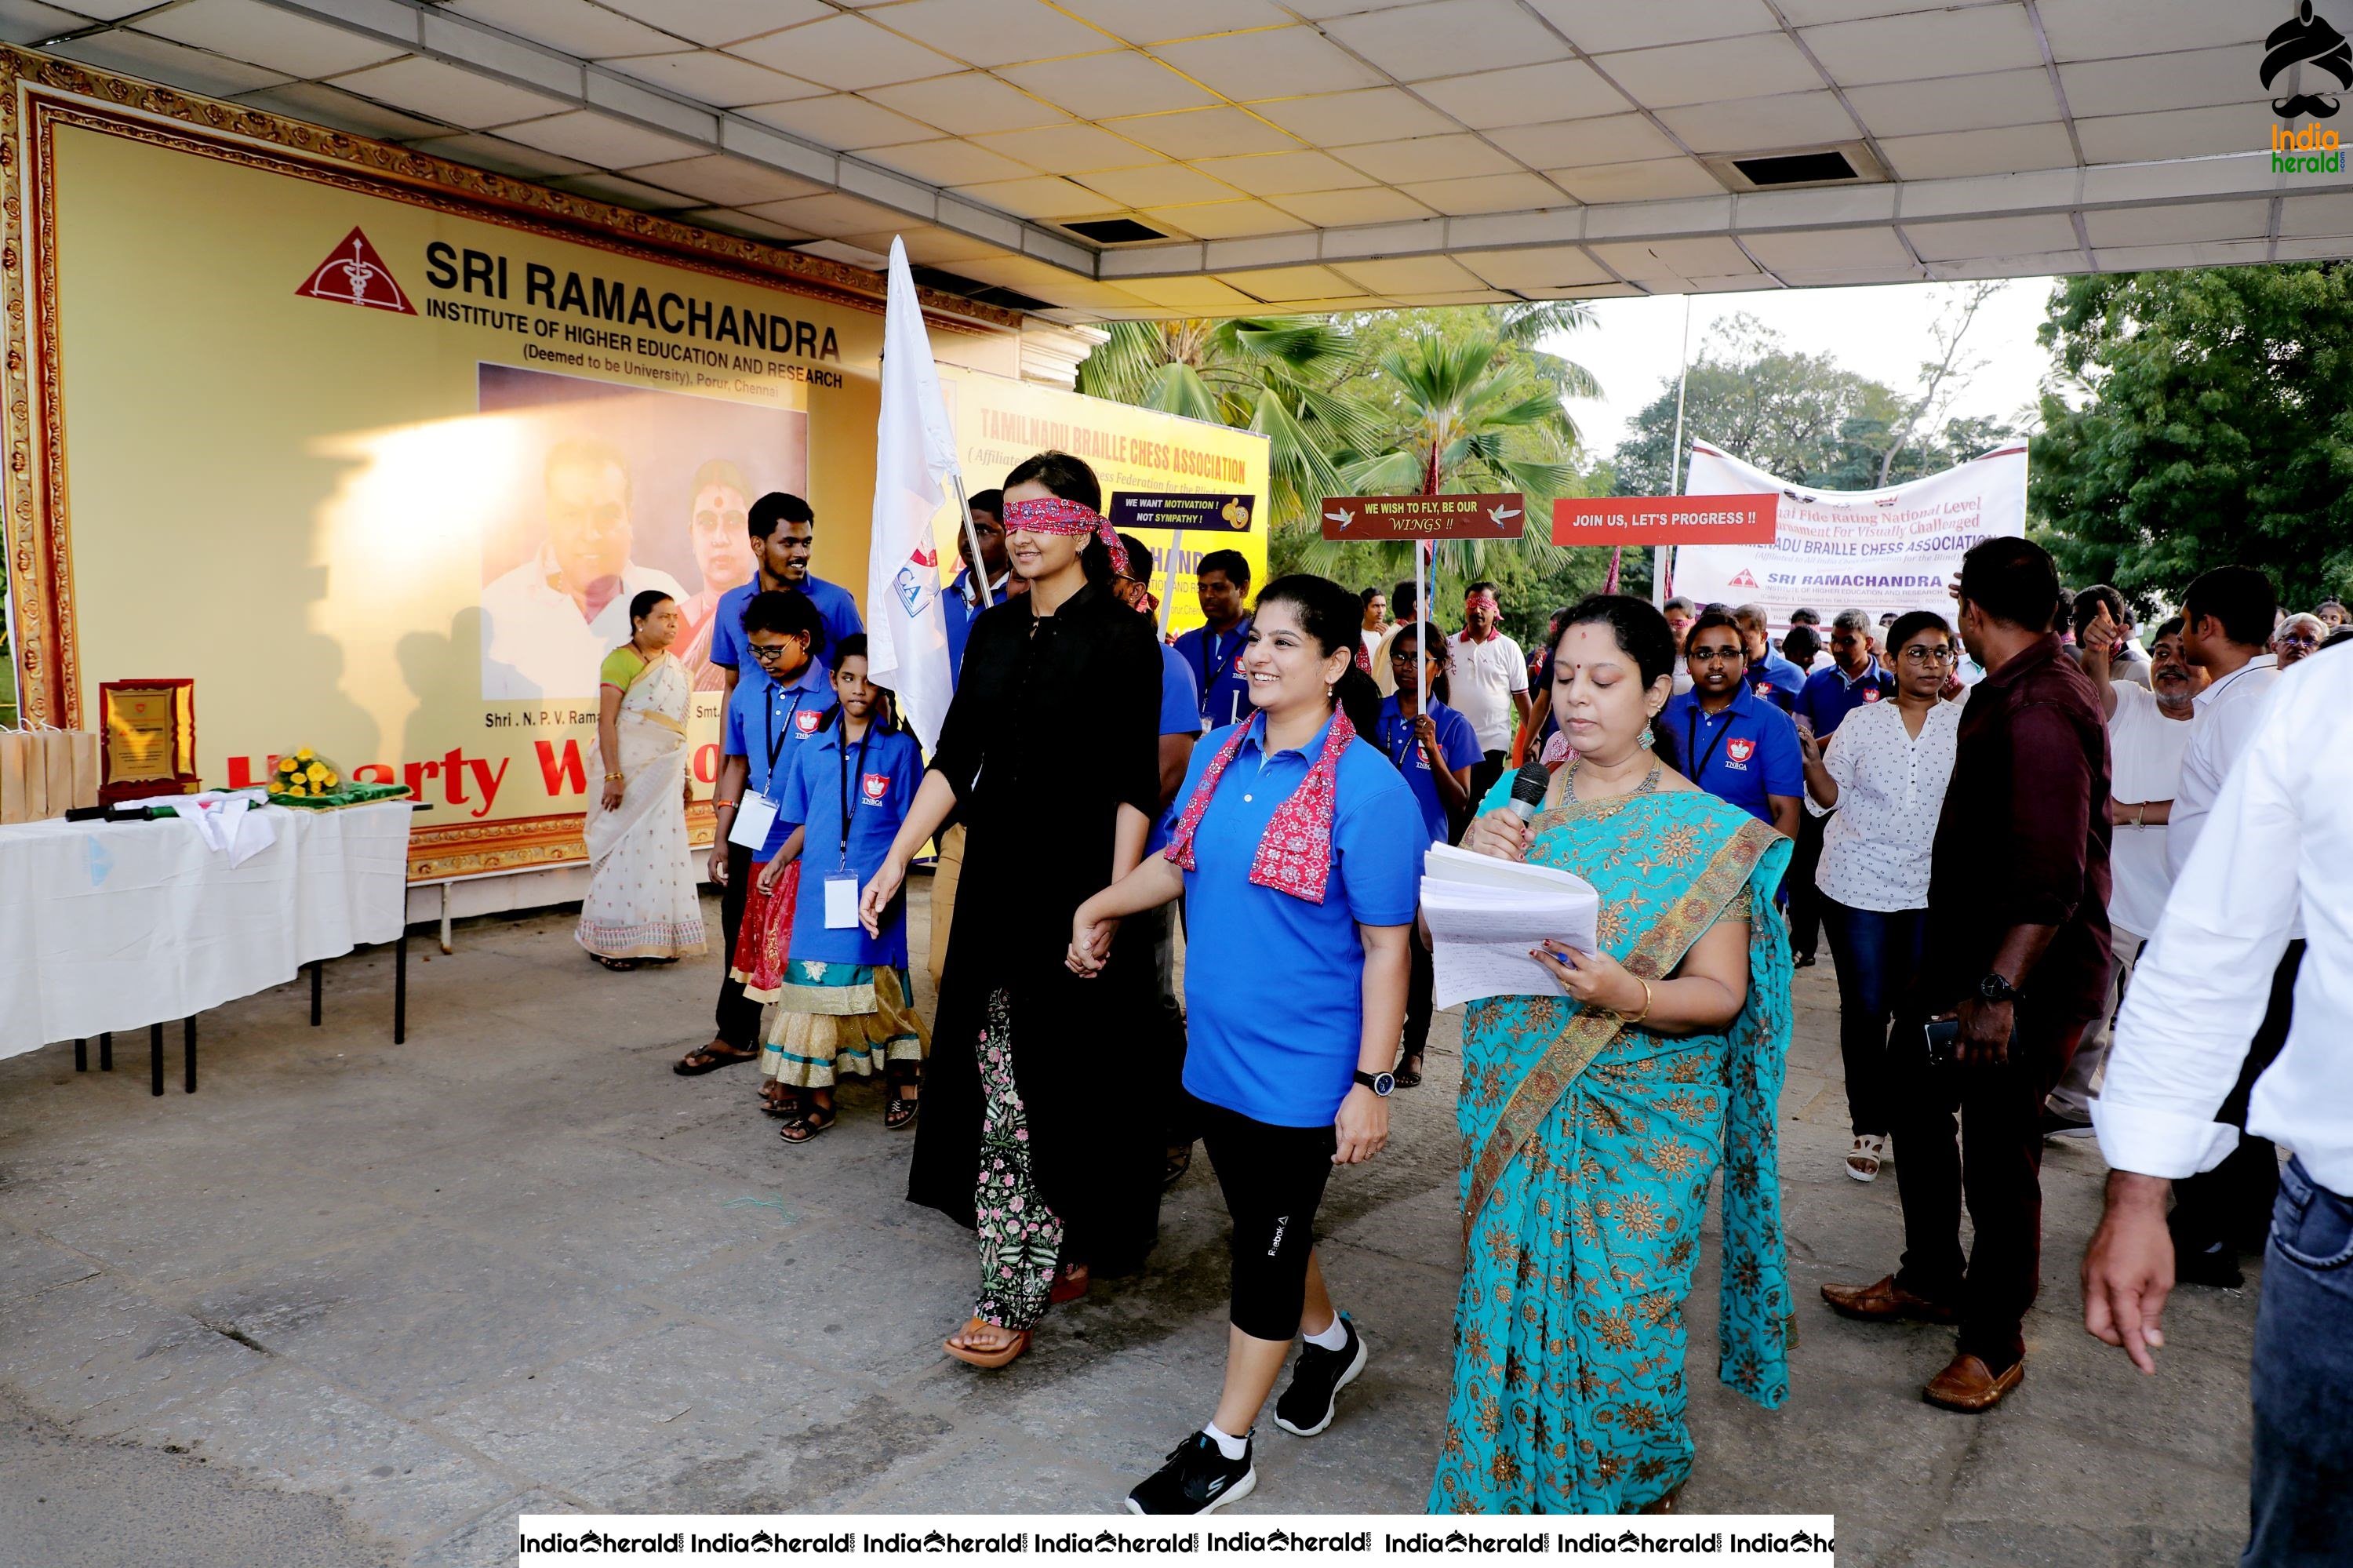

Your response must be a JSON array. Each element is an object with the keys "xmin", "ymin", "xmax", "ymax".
[{"xmin": 2082, "ymin": 647, "xmax": 2353, "ymax": 1568}]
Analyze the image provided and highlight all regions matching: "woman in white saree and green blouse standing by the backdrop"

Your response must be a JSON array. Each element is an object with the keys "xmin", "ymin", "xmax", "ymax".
[{"xmin": 574, "ymin": 588, "xmax": 704, "ymax": 970}]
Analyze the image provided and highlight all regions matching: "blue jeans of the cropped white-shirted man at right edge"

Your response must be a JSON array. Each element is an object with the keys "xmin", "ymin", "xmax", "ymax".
[{"xmin": 2240, "ymin": 1161, "xmax": 2353, "ymax": 1568}]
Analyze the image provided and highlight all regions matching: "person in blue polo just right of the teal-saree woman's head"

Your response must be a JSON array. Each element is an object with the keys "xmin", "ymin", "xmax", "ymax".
[{"xmin": 1659, "ymin": 609, "xmax": 1805, "ymax": 839}]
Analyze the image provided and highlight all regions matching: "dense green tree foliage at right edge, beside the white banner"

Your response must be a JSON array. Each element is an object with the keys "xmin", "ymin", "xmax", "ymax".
[{"xmin": 2028, "ymin": 264, "xmax": 2353, "ymax": 605}]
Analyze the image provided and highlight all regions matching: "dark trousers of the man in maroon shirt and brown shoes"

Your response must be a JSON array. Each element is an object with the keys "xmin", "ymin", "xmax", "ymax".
[{"xmin": 1887, "ymin": 1008, "xmax": 2085, "ymax": 1373}]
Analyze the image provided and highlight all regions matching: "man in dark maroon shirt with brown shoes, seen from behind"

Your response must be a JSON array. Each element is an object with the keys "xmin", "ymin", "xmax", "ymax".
[{"xmin": 1821, "ymin": 539, "xmax": 2108, "ymax": 1415}]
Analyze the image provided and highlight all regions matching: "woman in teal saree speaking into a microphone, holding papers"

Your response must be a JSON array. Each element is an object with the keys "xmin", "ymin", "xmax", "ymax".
[{"xmin": 1431, "ymin": 595, "xmax": 1793, "ymax": 1514}]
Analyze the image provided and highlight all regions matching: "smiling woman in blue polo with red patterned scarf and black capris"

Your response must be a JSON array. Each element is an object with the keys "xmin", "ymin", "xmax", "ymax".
[{"xmin": 1071, "ymin": 577, "xmax": 1424, "ymax": 1514}]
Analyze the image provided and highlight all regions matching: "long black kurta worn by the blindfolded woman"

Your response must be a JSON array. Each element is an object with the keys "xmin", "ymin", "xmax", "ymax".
[{"xmin": 908, "ymin": 584, "xmax": 1165, "ymax": 1274}]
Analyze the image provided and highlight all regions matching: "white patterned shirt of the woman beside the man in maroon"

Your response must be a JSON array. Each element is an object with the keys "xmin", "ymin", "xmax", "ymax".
[{"xmin": 1805, "ymin": 701, "xmax": 1960, "ymax": 911}]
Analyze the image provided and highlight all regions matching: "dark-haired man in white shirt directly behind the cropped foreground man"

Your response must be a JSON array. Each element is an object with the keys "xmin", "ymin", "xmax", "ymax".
[{"xmin": 2165, "ymin": 567, "xmax": 2304, "ymax": 1288}]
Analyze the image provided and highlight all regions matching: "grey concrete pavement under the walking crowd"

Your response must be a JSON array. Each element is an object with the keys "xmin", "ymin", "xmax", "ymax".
[{"xmin": 0, "ymin": 888, "xmax": 2254, "ymax": 1568}]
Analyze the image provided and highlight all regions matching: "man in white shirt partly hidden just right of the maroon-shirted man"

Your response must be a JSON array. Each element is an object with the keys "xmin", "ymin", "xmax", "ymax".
[{"xmin": 2042, "ymin": 605, "xmax": 2205, "ymax": 1137}]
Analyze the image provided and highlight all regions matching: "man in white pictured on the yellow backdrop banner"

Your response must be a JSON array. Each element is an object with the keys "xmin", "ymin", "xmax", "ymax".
[{"xmin": 482, "ymin": 440, "xmax": 687, "ymax": 701}]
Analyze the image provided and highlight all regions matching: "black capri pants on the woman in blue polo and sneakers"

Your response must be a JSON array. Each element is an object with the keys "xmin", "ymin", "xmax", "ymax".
[{"xmin": 1195, "ymin": 1102, "xmax": 1339, "ymax": 1342}]
